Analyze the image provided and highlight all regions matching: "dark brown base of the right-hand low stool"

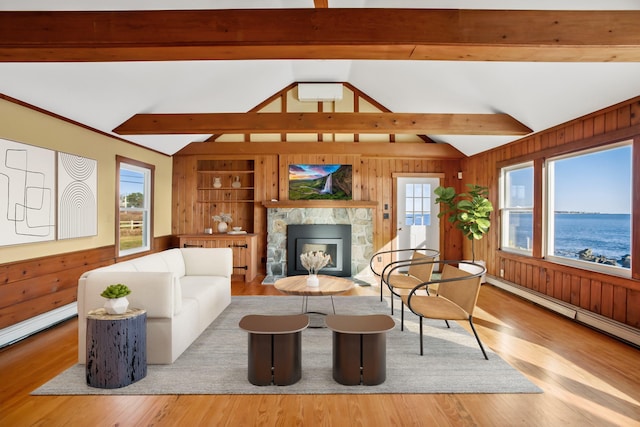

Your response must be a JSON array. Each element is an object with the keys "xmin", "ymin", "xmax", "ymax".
[{"xmin": 333, "ymin": 331, "xmax": 387, "ymax": 385}]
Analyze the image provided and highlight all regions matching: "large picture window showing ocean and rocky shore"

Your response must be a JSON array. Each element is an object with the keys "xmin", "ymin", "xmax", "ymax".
[{"xmin": 546, "ymin": 142, "xmax": 632, "ymax": 275}]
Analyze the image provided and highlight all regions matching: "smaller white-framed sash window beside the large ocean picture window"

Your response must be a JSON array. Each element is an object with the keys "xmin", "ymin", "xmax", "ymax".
[{"xmin": 500, "ymin": 163, "xmax": 533, "ymax": 255}]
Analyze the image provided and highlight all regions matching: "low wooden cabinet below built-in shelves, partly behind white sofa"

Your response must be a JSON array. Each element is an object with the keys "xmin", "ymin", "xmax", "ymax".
[{"xmin": 179, "ymin": 234, "xmax": 258, "ymax": 282}]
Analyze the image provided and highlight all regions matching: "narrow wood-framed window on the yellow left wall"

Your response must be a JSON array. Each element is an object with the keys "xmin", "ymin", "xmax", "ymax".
[{"xmin": 116, "ymin": 157, "xmax": 154, "ymax": 256}]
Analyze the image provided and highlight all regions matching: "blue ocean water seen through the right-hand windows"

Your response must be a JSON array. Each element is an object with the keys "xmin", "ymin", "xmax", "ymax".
[{"xmin": 512, "ymin": 213, "xmax": 631, "ymax": 266}]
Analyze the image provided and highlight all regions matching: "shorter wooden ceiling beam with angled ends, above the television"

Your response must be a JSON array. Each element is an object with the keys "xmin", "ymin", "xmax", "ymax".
[{"xmin": 113, "ymin": 112, "xmax": 532, "ymax": 135}]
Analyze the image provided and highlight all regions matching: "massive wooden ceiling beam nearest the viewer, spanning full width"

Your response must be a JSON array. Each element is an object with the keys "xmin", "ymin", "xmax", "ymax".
[{"xmin": 0, "ymin": 8, "xmax": 640, "ymax": 62}]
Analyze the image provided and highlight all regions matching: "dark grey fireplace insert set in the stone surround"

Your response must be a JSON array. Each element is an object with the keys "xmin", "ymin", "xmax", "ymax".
[{"xmin": 287, "ymin": 224, "xmax": 351, "ymax": 277}]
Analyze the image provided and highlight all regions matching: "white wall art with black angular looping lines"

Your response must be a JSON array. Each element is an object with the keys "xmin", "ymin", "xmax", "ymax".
[{"xmin": 0, "ymin": 138, "xmax": 56, "ymax": 246}]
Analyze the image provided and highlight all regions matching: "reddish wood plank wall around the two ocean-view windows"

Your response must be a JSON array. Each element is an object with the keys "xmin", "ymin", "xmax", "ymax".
[{"xmin": 462, "ymin": 97, "xmax": 640, "ymax": 328}]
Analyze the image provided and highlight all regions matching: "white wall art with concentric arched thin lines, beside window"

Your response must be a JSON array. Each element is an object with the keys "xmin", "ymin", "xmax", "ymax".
[{"xmin": 58, "ymin": 152, "xmax": 98, "ymax": 239}]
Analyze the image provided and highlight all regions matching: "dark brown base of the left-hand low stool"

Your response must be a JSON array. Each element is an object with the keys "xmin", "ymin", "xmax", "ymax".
[{"xmin": 248, "ymin": 332, "xmax": 302, "ymax": 385}]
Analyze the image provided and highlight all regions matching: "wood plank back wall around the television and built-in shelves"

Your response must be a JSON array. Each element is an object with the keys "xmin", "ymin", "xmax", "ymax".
[{"xmin": 172, "ymin": 154, "xmax": 461, "ymax": 269}]
